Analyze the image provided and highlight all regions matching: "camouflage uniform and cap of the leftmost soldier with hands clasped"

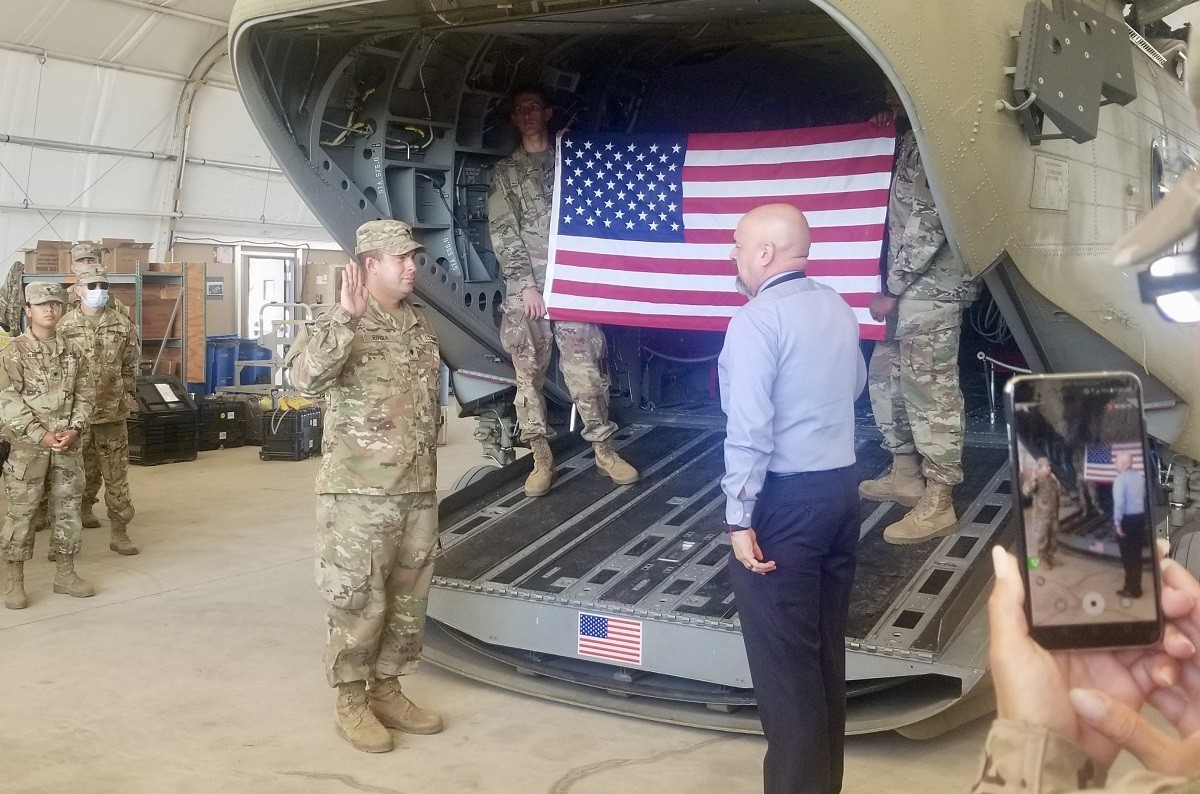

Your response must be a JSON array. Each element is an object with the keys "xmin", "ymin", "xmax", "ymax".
[{"xmin": 0, "ymin": 282, "xmax": 92, "ymax": 561}]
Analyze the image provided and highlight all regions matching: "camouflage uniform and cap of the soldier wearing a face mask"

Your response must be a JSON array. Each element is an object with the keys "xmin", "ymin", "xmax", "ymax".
[{"xmin": 58, "ymin": 266, "xmax": 142, "ymax": 527}]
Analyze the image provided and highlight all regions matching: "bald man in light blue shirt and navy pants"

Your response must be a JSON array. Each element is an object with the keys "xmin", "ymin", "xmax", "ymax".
[{"xmin": 718, "ymin": 204, "xmax": 866, "ymax": 793}]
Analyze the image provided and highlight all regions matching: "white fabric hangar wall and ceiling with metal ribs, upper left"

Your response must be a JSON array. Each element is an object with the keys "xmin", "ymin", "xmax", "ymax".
[{"xmin": 0, "ymin": 0, "xmax": 335, "ymax": 273}]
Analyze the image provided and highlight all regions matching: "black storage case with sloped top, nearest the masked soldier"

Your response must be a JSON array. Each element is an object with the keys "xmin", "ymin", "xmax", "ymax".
[{"xmin": 126, "ymin": 375, "xmax": 197, "ymax": 465}]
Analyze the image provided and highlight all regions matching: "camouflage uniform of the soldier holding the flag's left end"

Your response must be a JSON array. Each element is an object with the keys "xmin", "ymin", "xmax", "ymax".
[{"xmin": 487, "ymin": 146, "xmax": 617, "ymax": 441}]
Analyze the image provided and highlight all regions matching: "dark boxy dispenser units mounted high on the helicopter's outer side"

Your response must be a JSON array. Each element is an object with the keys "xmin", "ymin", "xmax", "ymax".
[{"xmin": 1004, "ymin": 0, "xmax": 1138, "ymax": 145}]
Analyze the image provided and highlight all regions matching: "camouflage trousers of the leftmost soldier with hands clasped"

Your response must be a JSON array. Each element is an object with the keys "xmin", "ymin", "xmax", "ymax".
[{"xmin": 0, "ymin": 449, "xmax": 83, "ymax": 560}]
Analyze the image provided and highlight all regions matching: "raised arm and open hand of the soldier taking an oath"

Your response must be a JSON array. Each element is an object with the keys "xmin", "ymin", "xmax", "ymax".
[{"xmin": 287, "ymin": 265, "xmax": 367, "ymax": 397}]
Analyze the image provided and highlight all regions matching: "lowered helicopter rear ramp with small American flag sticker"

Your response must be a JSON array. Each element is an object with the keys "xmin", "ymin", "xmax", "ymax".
[{"xmin": 426, "ymin": 426, "xmax": 1010, "ymax": 733}]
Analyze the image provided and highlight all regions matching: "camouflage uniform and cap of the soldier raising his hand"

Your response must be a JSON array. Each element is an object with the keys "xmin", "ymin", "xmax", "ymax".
[{"xmin": 288, "ymin": 221, "xmax": 440, "ymax": 686}]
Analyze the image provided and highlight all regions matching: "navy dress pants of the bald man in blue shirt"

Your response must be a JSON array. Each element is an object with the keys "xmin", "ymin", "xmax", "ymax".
[{"xmin": 730, "ymin": 467, "xmax": 860, "ymax": 794}]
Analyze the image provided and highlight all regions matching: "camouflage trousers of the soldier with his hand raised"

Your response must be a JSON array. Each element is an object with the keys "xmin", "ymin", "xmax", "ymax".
[{"xmin": 317, "ymin": 493, "xmax": 438, "ymax": 686}]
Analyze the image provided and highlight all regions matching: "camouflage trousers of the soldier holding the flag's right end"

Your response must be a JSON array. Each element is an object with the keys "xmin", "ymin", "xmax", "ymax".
[{"xmin": 868, "ymin": 297, "xmax": 966, "ymax": 486}]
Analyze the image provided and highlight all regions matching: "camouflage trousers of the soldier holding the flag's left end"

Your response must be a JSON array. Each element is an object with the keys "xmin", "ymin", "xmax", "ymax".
[{"xmin": 500, "ymin": 307, "xmax": 617, "ymax": 441}]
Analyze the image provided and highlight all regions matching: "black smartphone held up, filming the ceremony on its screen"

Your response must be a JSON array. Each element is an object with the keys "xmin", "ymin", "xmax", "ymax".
[{"xmin": 1004, "ymin": 372, "xmax": 1163, "ymax": 649}]
